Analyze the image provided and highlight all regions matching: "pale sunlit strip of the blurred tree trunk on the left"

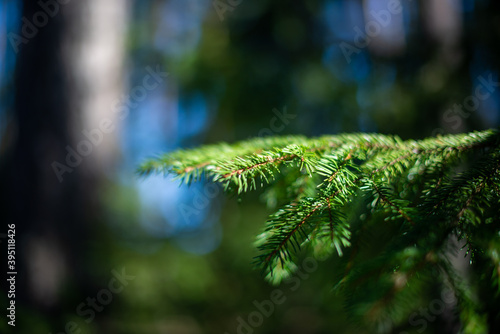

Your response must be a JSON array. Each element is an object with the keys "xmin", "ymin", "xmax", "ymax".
[{"xmin": 64, "ymin": 0, "xmax": 130, "ymax": 174}]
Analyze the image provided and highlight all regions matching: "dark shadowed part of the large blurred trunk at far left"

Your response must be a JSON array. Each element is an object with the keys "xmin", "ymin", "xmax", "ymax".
[{"xmin": 0, "ymin": 0, "xmax": 126, "ymax": 332}]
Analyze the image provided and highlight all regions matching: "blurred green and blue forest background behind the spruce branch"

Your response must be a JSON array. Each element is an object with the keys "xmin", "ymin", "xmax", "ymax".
[{"xmin": 0, "ymin": 0, "xmax": 500, "ymax": 334}]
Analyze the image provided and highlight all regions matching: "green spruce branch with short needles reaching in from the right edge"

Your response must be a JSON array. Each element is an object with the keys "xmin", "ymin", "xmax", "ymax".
[{"xmin": 139, "ymin": 130, "xmax": 500, "ymax": 333}]
